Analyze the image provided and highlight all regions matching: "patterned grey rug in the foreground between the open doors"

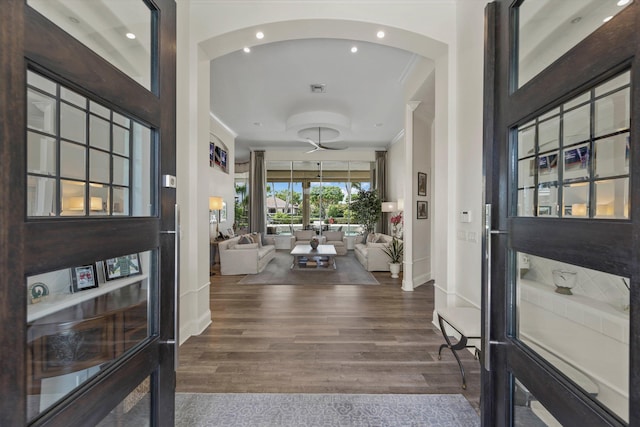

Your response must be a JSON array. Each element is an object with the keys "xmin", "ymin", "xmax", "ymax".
[{"xmin": 176, "ymin": 393, "xmax": 480, "ymax": 427}]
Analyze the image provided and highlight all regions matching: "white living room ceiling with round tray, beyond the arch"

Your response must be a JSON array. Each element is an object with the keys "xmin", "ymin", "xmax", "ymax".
[{"xmin": 211, "ymin": 39, "xmax": 420, "ymax": 161}]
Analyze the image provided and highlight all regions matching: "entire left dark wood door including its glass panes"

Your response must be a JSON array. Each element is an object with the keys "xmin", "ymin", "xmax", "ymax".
[{"xmin": 0, "ymin": 0, "xmax": 178, "ymax": 426}]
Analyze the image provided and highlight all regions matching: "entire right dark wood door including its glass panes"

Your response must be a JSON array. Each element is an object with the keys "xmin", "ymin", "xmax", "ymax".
[{"xmin": 482, "ymin": 0, "xmax": 640, "ymax": 426}]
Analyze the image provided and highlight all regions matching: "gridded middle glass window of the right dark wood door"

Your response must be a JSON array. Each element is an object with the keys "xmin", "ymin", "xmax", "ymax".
[{"xmin": 512, "ymin": 71, "xmax": 631, "ymax": 219}]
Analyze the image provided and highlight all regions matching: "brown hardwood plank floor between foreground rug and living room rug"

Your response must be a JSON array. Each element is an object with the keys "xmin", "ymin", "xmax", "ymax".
[{"xmin": 177, "ymin": 273, "xmax": 480, "ymax": 410}]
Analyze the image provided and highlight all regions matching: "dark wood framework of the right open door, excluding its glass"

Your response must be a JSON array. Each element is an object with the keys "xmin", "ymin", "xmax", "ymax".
[{"xmin": 482, "ymin": 0, "xmax": 640, "ymax": 426}]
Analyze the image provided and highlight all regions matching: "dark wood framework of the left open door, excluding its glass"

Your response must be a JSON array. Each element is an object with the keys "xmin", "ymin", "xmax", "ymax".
[{"xmin": 0, "ymin": 0, "xmax": 176, "ymax": 426}]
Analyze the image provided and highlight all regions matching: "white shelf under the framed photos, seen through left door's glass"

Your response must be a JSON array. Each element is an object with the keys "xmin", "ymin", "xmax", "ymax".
[{"xmin": 27, "ymin": 274, "xmax": 148, "ymax": 323}]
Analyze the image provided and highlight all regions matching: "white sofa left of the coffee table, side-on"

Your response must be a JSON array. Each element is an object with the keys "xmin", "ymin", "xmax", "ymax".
[{"xmin": 218, "ymin": 234, "xmax": 276, "ymax": 276}]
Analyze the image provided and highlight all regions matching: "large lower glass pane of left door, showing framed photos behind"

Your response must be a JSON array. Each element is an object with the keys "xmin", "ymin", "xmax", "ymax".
[{"xmin": 25, "ymin": 251, "xmax": 157, "ymax": 419}]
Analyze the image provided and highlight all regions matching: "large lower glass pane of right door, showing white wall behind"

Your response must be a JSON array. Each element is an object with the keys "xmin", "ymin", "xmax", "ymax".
[{"xmin": 515, "ymin": 253, "xmax": 630, "ymax": 419}]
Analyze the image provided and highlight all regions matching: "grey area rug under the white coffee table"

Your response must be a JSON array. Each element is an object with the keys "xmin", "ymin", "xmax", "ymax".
[{"xmin": 238, "ymin": 250, "xmax": 380, "ymax": 285}]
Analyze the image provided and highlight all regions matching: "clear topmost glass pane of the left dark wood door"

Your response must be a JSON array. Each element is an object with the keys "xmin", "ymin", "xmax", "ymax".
[{"xmin": 27, "ymin": 0, "xmax": 155, "ymax": 89}]
